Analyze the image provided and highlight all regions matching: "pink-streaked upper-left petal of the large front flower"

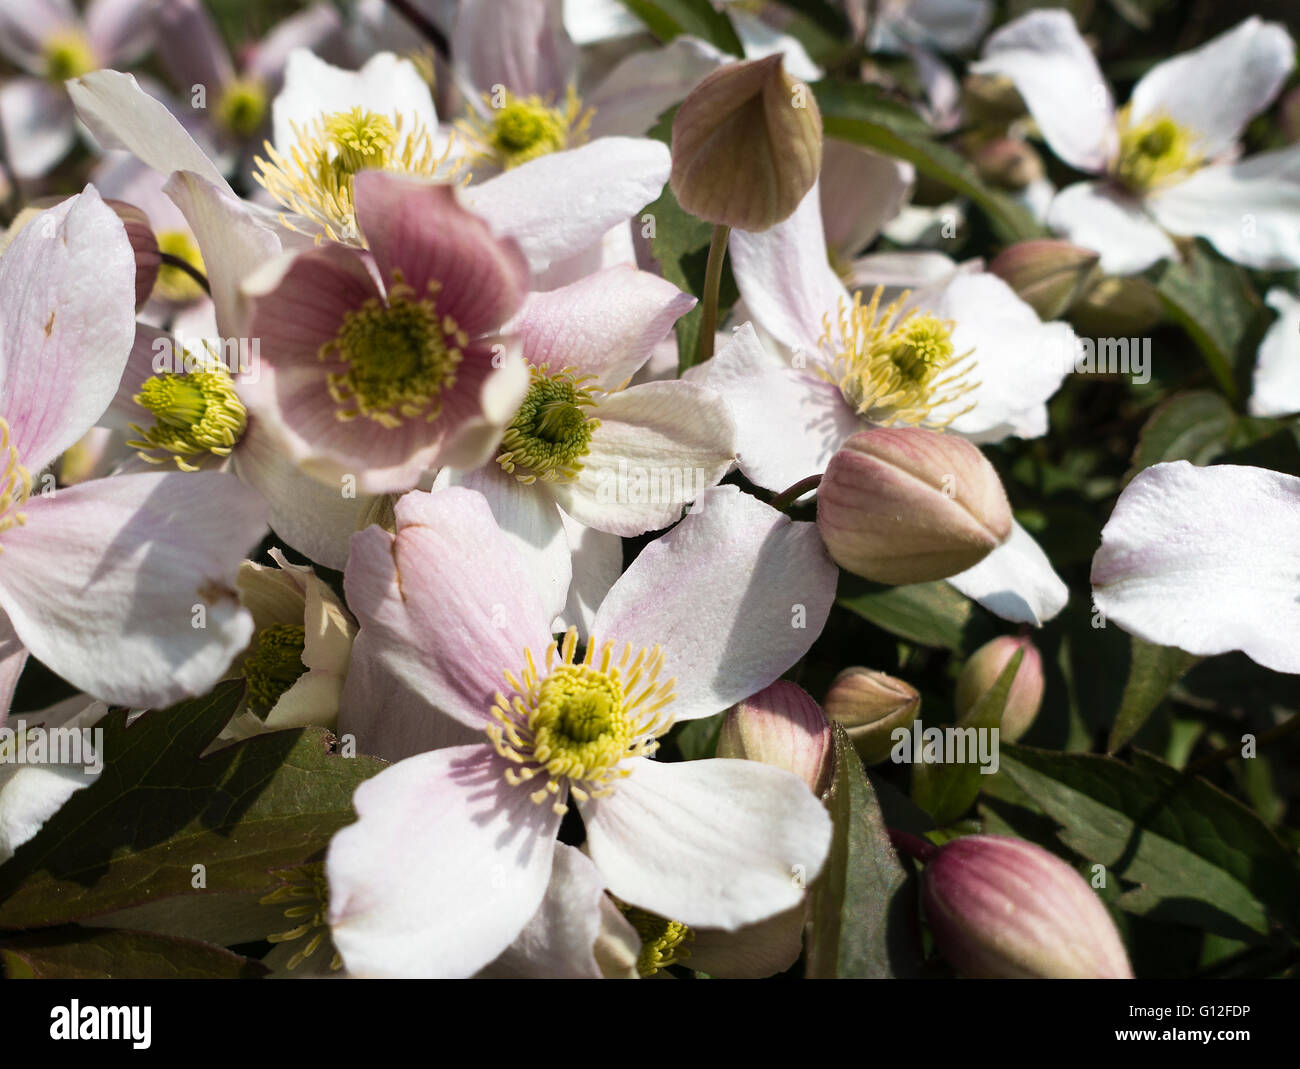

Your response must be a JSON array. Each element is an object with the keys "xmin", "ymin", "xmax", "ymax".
[{"xmin": 345, "ymin": 486, "xmax": 551, "ymax": 728}]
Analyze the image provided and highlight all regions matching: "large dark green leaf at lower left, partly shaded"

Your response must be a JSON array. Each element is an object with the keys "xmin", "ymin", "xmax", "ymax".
[{"xmin": 0, "ymin": 681, "xmax": 384, "ymax": 929}]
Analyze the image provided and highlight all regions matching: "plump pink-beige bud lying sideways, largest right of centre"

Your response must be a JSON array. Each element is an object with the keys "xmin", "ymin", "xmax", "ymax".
[{"xmin": 816, "ymin": 427, "xmax": 1011, "ymax": 584}]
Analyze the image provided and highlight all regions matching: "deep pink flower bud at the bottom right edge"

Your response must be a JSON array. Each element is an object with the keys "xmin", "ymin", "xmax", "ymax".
[{"xmin": 922, "ymin": 835, "xmax": 1132, "ymax": 979}]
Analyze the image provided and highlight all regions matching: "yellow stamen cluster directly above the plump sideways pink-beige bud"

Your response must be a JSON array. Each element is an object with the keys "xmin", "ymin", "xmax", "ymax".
[{"xmin": 819, "ymin": 286, "xmax": 979, "ymax": 430}]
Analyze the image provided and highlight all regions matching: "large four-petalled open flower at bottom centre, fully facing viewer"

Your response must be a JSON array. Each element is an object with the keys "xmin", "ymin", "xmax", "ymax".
[{"xmin": 326, "ymin": 486, "xmax": 836, "ymax": 975}]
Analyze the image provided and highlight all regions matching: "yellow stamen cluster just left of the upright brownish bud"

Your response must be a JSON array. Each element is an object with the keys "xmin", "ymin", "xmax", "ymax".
[{"xmin": 456, "ymin": 86, "xmax": 595, "ymax": 170}]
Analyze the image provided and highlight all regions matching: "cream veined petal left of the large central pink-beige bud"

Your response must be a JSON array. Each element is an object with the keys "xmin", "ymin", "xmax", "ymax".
[{"xmin": 551, "ymin": 382, "xmax": 736, "ymax": 536}]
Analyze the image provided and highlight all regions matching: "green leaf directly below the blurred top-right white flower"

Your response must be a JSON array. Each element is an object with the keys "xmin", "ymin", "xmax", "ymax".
[{"xmin": 1151, "ymin": 238, "xmax": 1271, "ymax": 401}]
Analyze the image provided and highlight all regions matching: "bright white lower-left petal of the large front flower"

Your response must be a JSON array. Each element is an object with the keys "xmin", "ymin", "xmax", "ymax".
[{"xmin": 325, "ymin": 745, "xmax": 560, "ymax": 978}]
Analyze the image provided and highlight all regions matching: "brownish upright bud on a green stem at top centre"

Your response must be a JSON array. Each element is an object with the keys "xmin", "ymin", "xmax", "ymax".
[{"xmin": 668, "ymin": 55, "xmax": 822, "ymax": 230}]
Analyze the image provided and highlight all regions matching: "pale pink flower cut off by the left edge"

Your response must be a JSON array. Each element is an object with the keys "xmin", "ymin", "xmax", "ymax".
[{"xmin": 0, "ymin": 186, "xmax": 265, "ymax": 728}]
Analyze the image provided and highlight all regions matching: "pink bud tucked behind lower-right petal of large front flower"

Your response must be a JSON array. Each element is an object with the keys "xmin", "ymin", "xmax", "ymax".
[{"xmin": 718, "ymin": 679, "xmax": 835, "ymax": 797}]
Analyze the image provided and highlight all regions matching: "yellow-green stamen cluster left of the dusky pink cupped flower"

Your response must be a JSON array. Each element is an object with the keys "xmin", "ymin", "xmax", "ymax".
[{"xmin": 127, "ymin": 354, "xmax": 248, "ymax": 471}]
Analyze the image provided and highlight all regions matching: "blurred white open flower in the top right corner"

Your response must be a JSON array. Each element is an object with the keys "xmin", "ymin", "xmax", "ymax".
[{"xmin": 971, "ymin": 10, "xmax": 1300, "ymax": 274}]
